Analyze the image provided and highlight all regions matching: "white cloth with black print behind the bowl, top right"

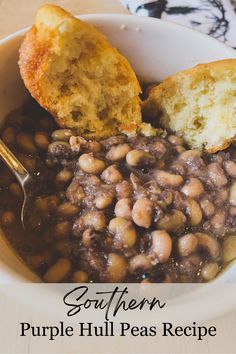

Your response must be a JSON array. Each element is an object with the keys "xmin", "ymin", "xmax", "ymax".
[{"xmin": 121, "ymin": 0, "xmax": 236, "ymax": 48}]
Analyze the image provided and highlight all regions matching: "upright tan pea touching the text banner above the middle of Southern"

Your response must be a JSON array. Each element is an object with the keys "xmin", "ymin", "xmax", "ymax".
[{"xmin": 107, "ymin": 253, "xmax": 127, "ymax": 283}]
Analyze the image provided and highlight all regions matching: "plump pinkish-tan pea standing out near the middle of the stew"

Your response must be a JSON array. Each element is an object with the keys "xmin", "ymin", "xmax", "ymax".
[{"xmin": 132, "ymin": 198, "xmax": 153, "ymax": 229}]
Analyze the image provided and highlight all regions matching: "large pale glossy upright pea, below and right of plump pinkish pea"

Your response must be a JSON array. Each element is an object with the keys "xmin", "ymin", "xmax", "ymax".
[{"xmin": 151, "ymin": 231, "xmax": 172, "ymax": 263}]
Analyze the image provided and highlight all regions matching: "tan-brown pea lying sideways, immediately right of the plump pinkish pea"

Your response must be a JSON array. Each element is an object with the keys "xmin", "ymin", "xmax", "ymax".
[{"xmin": 157, "ymin": 209, "xmax": 186, "ymax": 232}]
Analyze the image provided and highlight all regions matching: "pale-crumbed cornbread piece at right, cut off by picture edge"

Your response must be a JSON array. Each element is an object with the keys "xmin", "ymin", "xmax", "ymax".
[{"xmin": 142, "ymin": 59, "xmax": 236, "ymax": 153}]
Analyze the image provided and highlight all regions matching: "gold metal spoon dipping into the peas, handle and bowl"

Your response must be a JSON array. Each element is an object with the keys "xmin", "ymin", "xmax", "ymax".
[{"xmin": 0, "ymin": 139, "xmax": 34, "ymax": 228}]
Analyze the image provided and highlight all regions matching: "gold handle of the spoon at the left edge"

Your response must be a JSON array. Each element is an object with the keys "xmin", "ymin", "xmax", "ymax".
[{"xmin": 0, "ymin": 139, "xmax": 29, "ymax": 184}]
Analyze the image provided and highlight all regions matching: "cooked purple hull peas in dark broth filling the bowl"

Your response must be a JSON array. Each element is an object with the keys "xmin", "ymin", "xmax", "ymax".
[{"xmin": 0, "ymin": 102, "xmax": 236, "ymax": 283}]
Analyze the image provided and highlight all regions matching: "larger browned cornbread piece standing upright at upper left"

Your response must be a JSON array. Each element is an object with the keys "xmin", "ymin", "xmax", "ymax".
[{"xmin": 19, "ymin": 5, "xmax": 141, "ymax": 138}]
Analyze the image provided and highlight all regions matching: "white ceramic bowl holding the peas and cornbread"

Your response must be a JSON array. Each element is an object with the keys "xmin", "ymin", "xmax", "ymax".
[{"xmin": 0, "ymin": 14, "xmax": 236, "ymax": 306}]
